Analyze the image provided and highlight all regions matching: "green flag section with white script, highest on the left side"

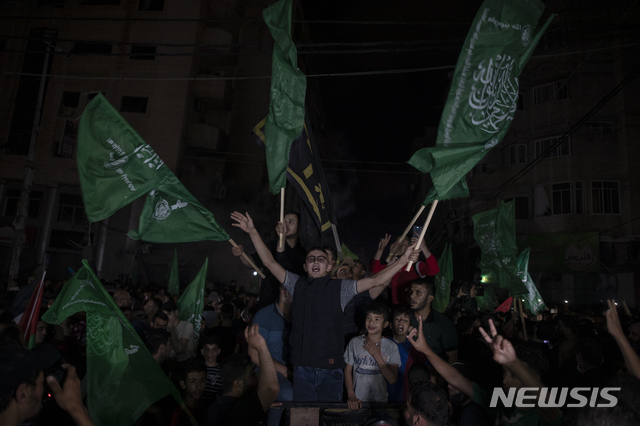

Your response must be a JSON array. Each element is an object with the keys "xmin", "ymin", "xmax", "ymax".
[{"xmin": 77, "ymin": 94, "xmax": 171, "ymax": 222}]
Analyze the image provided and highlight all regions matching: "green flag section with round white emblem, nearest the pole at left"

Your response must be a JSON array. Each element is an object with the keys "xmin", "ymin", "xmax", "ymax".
[{"xmin": 129, "ymin": 172, "xmax": 229, "ymax": 243}]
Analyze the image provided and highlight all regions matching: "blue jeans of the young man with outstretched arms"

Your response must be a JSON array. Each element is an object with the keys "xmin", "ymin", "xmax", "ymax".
[{"xmin": 293, "ymin": 366, "xmax": 344, "ymax": 402}]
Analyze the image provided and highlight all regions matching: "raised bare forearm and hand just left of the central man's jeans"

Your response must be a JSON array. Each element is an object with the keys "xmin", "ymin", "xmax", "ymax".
[{"xmin": 244, "ymin": 324, "xmax": 280, "ymax": 412}]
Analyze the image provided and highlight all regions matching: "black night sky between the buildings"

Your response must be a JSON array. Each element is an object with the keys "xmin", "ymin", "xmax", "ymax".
[{"xmin": 294, "ymin": 0, "xmax": 481, "ymax": 259}]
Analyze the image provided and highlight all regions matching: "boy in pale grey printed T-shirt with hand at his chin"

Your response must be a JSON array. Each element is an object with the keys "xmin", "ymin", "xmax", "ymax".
[{"xmin": 344, "ymin": 301, "xmax": 400, "ymax": 410}]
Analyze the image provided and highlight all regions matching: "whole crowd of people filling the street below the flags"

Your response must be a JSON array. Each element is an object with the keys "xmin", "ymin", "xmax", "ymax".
[{"xmin": 0, "ymin": 212, "xmax": 640, "ymax": 426}]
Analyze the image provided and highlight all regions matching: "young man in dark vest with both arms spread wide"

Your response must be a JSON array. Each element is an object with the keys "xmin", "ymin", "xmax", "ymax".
[{"xmin": 231, "ymin": 212, "xmax": 417, "ymax": 402}]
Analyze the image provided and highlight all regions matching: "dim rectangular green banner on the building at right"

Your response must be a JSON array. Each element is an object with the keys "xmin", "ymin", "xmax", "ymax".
[{"xmin": 518, "ymin": 232, "xmax": 600, "ymax": 274}]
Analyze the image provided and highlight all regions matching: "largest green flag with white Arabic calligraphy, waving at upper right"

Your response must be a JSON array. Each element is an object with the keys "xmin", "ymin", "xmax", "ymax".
[{"xmin": 409, "ymin": 0, "xmax": 553, "ymax": 200}]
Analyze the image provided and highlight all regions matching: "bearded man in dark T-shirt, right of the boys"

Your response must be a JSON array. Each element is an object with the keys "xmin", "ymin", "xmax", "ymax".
[{"xmin": 409, "ymin": 279, "xmax": 458, "ymax": 364}]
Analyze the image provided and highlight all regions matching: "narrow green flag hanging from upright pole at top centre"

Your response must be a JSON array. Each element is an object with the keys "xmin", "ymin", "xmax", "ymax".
[{"xmin": 262, "ymin": 0, "xmax": 307, "ymax": 194}]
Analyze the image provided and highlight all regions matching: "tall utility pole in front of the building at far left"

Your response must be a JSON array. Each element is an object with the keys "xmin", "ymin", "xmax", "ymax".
[{"xmin": 8, "ymin": 33, "xmax": 52, "ymax": 285}]
